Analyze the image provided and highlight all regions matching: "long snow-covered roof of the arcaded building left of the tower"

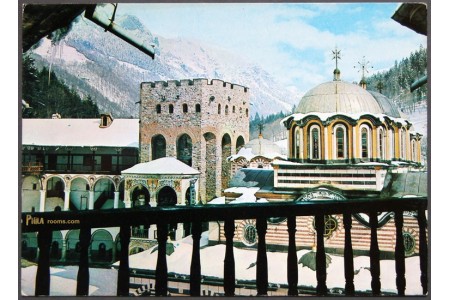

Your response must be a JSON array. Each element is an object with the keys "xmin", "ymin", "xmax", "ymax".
[{"xmin": 22, "ymin": 118, "xmax": 139, "ymax": 148}]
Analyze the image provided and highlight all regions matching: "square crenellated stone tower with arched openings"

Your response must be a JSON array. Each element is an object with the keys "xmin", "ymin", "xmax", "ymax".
[{"xmin": 139, "ymin": 79, "xmax": 250, "ymax": 202}]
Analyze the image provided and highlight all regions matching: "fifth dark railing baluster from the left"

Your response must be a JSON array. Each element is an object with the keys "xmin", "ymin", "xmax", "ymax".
[{"xmin": 190, "ymin": 222, "xmax": 202, "ymax": 296}]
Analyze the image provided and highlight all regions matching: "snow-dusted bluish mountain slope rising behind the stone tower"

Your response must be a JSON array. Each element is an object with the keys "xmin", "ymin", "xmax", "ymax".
[{"xmin": 27, "ymin": 16, "xmax": 299, "ymax": 117}]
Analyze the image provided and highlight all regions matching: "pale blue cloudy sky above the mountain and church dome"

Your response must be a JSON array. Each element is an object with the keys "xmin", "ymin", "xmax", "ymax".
[{"xmin": 117, "ymin": 3, "xmax": 427, "ymax": 93}]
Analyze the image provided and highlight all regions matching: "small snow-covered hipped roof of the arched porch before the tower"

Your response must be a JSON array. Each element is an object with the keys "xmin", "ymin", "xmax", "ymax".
[{"xmin": 122, "ymin": 157, "xmax": 200, "ymax": 175}]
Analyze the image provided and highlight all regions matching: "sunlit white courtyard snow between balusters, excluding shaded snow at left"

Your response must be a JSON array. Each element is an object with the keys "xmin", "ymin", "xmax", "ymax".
[{"xmin": 121, "ymin": 239, "xmax": 422, "ymax": 295}]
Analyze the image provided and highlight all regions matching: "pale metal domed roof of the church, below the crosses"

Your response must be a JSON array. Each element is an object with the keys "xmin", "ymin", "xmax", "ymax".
[{"xmin": 296, "ymin": 80, "xmax": 400, "ymax": 118}]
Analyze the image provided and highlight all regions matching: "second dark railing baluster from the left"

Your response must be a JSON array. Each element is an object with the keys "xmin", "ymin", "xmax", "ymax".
[{"xmin": 77, "ymin": 227, "xmax": 91, "ymax": 296}]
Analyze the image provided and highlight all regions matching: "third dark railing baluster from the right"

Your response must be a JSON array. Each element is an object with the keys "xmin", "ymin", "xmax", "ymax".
[{"xmin": 369, "ymin": 212, "xmax": 381, "ymax": 296}]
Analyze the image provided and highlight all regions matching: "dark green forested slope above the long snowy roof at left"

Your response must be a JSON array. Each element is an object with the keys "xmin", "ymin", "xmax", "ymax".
[{"xmin": 22, "ymin": 56, "xmax": 99, "ymax": 118}]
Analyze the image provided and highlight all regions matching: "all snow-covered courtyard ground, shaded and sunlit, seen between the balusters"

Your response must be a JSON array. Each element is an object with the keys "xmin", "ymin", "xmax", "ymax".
[{"xmin": 21, "ymin": 232, "xmax": 422, "ymax": 296}]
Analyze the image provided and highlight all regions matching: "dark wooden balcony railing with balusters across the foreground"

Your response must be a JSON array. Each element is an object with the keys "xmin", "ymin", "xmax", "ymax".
[{"xmin": 22, "ymin": 198, "xmax": 428, "ymax": 296}]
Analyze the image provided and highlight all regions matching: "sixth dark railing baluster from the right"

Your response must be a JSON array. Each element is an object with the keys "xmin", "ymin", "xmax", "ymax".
[{"xmin": 287, "ymin": 216, "xmax": 298, "ymax": 296}]
